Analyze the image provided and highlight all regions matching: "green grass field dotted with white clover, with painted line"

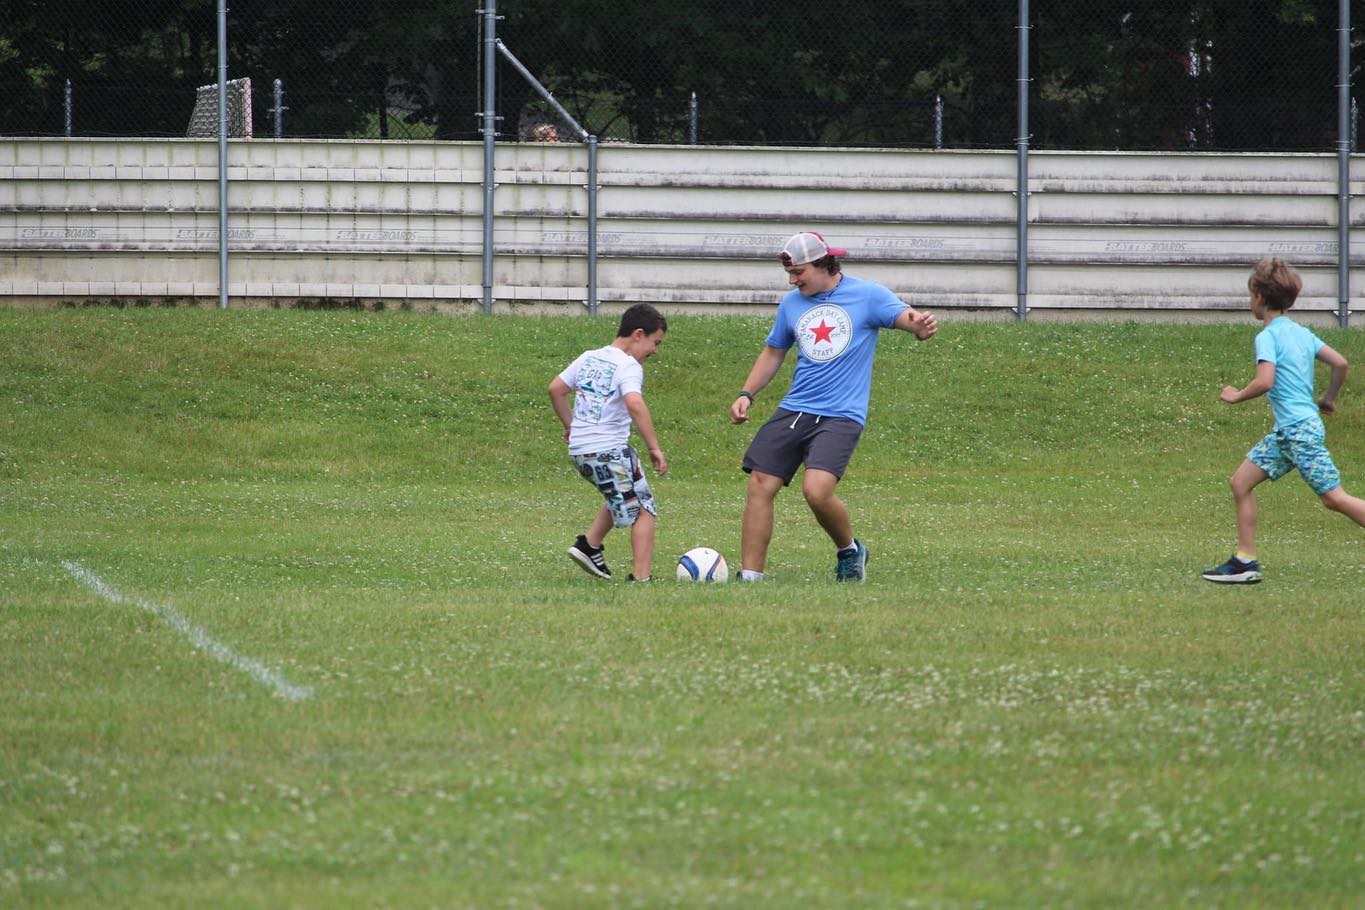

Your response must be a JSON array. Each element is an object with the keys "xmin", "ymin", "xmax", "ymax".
[{"xmin": 0, "ymin": 310, "xmax": 1365, "ymax": 909}]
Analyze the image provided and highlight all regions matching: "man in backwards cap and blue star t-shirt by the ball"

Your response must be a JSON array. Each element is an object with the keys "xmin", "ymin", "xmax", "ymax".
[{"xmin": 730, "ymin": 231, "xmax": 938, "ymax": 581}]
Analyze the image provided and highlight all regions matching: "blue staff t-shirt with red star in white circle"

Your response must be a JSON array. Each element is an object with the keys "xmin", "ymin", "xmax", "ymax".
[{"xmin": 766, "ymin": 276, "xmax": 908, "ymax": 424}]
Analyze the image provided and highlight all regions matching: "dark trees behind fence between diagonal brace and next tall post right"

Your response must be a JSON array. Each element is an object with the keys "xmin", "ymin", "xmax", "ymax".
[{"xmin": 500, "ymin": 0, "xmax": 1014, "ymax": 146}]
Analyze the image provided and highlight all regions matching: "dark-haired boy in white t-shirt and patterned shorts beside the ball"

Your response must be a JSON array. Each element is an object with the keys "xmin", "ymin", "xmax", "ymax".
[{"xmin": 550, "ymin": 303, "xmax": 669, "ymax": 581}]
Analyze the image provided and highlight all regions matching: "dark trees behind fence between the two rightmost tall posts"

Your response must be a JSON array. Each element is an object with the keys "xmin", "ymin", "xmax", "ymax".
[{"xmin": 1031, "ymin": 0, "xmax": 1338, "ymax": 150}]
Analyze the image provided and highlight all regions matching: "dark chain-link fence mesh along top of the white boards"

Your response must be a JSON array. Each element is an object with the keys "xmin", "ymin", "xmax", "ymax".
[{"xmin": 0, "ymin": 0, "xmax": 1365, "ymax": 151}]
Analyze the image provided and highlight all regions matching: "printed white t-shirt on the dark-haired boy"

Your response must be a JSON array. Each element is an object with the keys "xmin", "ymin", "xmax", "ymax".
[{"xmin": 560, "ymin": 345, "xmax": 644, "ymax": 454}]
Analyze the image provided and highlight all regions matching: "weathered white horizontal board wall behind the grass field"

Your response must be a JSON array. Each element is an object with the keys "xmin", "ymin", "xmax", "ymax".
[{"xmin": 0, "ymin": 139, "xmax": 1365, "ymax": 318}]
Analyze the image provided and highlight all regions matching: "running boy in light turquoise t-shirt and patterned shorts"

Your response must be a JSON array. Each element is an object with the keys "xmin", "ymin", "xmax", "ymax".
[{"xmin": 1203, "ymin": 258, "xmax": 1365, "ymax": 584}]
